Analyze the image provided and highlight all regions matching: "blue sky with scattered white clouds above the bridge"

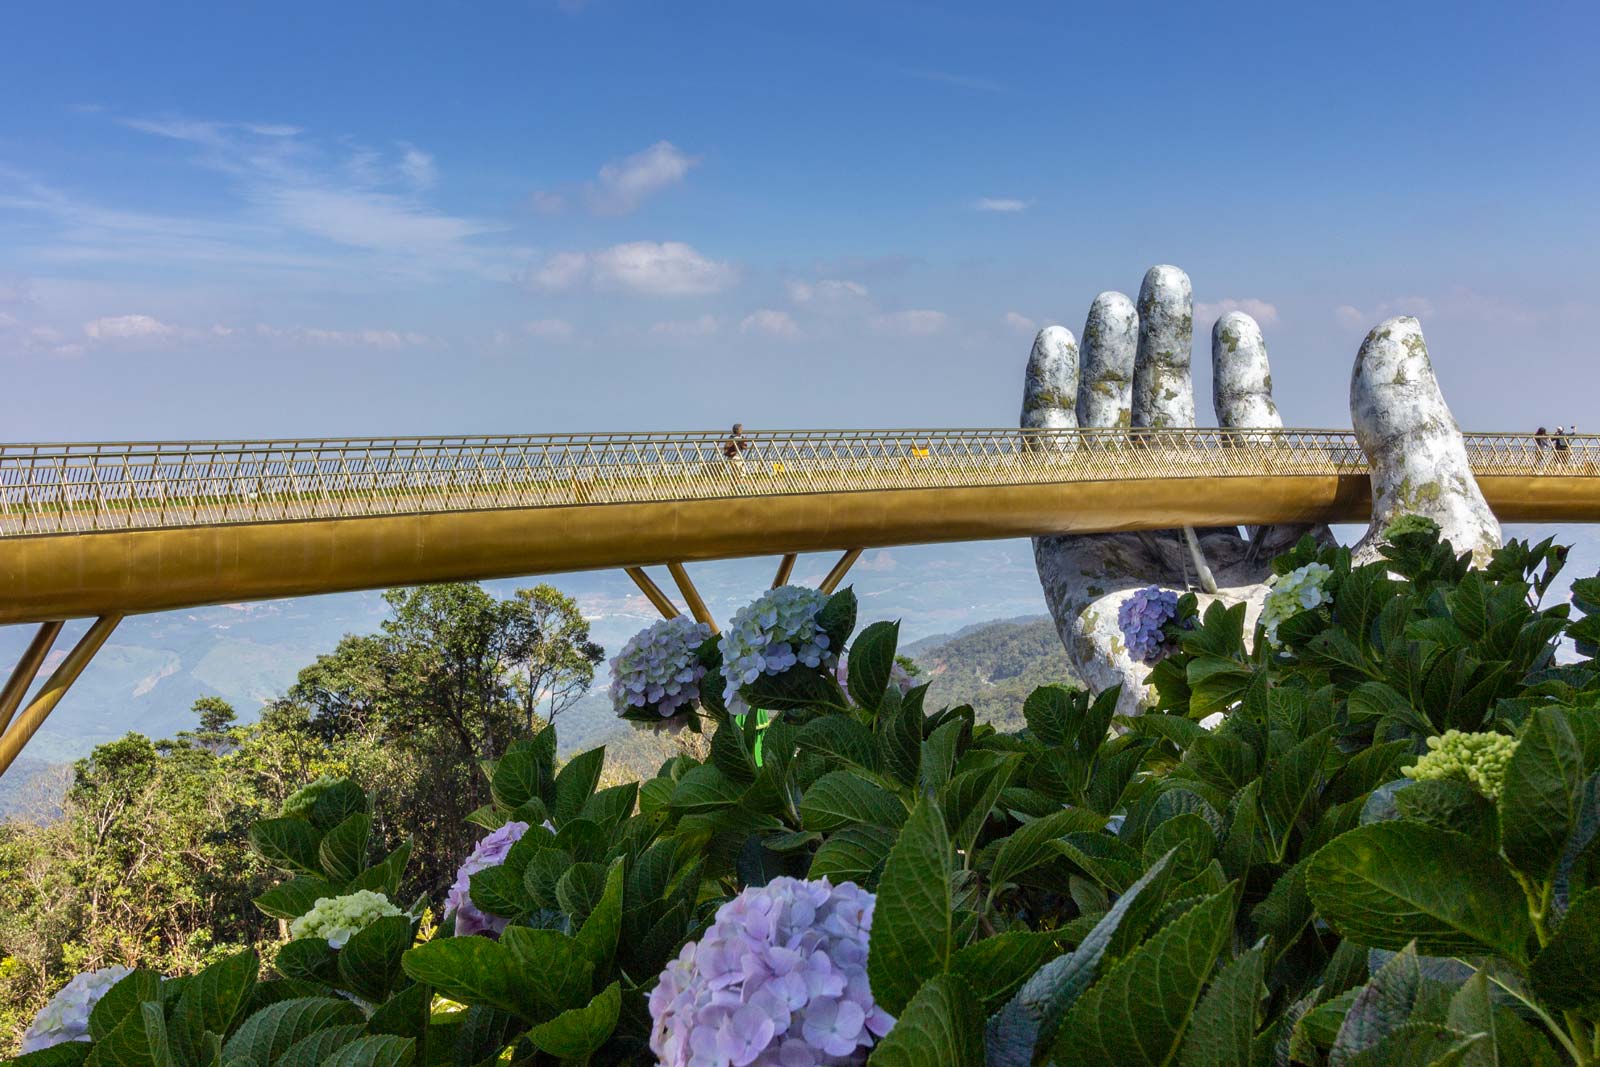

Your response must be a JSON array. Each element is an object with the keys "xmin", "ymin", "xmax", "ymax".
[{"xmin": 0, "ymin": 0, "xmax": 1600, "ymax": 440}]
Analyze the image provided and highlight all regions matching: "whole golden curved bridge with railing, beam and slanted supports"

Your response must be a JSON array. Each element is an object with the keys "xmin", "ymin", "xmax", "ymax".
[{"xmin": 0, "ymin": 429, "xmax": 1600, "ymax": 773}]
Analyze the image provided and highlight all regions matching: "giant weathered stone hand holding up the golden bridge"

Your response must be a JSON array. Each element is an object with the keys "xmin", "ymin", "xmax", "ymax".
[{"xmin": 1021, "ymin": 266, "xmax": 1499, "ymax": 713}]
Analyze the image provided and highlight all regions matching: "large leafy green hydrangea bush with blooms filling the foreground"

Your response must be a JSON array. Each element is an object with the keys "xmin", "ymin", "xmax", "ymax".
[{"xmin": 22, "ymin": 526, "xmax": 1600, "ymax": 1067}]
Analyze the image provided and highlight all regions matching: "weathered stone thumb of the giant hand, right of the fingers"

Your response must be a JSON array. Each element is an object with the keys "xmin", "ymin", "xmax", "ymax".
[{"xmin": 1350, "ymin": 315, "xmax": 1501, "ymax": 565}]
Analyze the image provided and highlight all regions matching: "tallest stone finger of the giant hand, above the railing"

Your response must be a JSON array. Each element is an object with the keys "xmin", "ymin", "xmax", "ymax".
[{"xmin": 1133, "ymin": 264, "xmax": 1195, "ymax": 427}]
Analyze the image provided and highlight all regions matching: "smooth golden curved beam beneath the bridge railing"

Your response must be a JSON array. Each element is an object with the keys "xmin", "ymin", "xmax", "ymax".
[{"xmin": 0, "ymin": 474, "xmax": 1600, "ymax": 624}]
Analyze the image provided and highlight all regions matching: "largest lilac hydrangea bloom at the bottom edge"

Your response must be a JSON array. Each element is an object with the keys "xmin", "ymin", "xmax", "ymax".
[{"xmin": 650, "ymin": 878, "xmax": 894, "ymax": 1067}]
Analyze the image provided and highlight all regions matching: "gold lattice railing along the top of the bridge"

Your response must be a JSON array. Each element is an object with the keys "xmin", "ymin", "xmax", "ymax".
[{"xmin": 0, "ymin": 429, "xmax": 1600, "ymax": 536}]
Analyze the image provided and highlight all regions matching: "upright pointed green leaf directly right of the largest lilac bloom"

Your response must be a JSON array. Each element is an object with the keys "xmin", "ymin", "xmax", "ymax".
[{"xmin": 867, "ymin": 797, "xmax": 955, "ymax": 1016}]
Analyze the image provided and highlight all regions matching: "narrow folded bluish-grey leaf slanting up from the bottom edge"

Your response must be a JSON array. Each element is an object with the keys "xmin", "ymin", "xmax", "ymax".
[{"xmin": 985, "ymin": 857, "xmax": 1168, "ymax": 1067}]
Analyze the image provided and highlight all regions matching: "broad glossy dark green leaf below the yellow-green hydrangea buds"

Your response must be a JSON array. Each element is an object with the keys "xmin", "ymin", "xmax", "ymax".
[{"xmin": 1306, "ymin": 822, "xmax": 1533, "ymax": 960}]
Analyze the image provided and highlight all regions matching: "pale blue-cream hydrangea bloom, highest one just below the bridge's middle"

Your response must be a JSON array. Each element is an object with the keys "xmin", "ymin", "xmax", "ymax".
[{"xmin": 717, "ymin": 585, "xmax": 837, "ymax": 715}]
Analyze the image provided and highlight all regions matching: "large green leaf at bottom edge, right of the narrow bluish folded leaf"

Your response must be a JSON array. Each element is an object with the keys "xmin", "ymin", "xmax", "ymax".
[{"xmin": 1056, "ymin": 891, "xmax": 1234, "ymax": 1067}]
